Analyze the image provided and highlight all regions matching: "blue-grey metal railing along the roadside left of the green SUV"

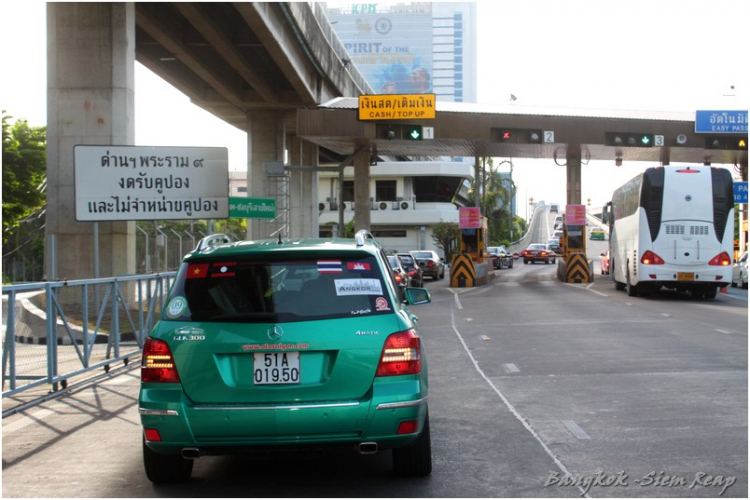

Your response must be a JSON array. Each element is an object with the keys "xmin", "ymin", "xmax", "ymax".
[{"xmin": 2, "ymin": 272, "xmax": 176, "ymax": 400}]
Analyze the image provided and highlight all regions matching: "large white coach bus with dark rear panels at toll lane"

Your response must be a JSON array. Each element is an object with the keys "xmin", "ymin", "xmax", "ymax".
[{"xmin": 604, "ymin": 167, "xmax": 734, "ymax": 298}]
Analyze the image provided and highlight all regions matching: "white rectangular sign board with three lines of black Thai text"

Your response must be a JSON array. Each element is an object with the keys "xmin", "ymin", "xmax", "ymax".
[{"xmin": 73, "ymin": 145, "xmax": 229, "ymax": 221}]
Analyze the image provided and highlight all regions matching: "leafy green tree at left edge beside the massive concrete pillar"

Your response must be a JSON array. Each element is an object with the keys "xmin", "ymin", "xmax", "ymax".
[{"xmin": 2, "ymin": 111, "xmax": 47, "ymax": 281}]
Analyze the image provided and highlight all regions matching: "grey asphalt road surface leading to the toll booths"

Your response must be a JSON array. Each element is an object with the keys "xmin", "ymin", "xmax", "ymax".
[{"xmin": 2, "ymin": 237, "xmax": 748, "ymax": 498}]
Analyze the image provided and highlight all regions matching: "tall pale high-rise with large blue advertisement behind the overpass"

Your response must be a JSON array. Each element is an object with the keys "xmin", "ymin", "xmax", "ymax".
[{"xmin": 326, "ymin": 2, "xmax": 477, "ymax": 102}]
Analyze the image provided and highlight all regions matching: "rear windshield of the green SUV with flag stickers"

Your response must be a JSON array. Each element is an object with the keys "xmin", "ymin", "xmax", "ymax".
[{"xmin": 163, "ymin": 255, "xmax": 393, "ymax": 323}]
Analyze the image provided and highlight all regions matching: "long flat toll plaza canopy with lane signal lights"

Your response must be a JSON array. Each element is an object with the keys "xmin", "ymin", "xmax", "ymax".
[{"xmin": 297, "ymin": 97, "xmax": 747, "ymax": 169}]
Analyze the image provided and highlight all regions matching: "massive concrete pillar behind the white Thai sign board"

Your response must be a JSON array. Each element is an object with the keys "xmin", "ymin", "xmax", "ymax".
[{"xmin": 45, "ymin": 2, "xmax": 135, "ymax": 280}]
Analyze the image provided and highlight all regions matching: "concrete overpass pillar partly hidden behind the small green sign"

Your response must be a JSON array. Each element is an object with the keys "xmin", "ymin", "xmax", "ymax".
[{"xmin": 247, "ymin": 110, "xmax": 286, "ymax": 240}]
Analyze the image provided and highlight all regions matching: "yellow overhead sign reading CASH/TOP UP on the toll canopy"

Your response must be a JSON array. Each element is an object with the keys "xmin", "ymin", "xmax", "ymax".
[{"xmin": 359, "ymin": 94, "xmax": 435, "ymax": 120}]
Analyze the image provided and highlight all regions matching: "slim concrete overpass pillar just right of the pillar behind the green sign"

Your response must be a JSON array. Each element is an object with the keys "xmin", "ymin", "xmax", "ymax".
[{"xmin": 289, "ymin": 136, "xmax": 319, "ymax": 238}]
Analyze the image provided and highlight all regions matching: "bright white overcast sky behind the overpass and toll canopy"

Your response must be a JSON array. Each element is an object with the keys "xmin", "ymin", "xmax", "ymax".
[{"xmin": 0, "ymin": 0, "xmax": 750, "ymax": 211}]
